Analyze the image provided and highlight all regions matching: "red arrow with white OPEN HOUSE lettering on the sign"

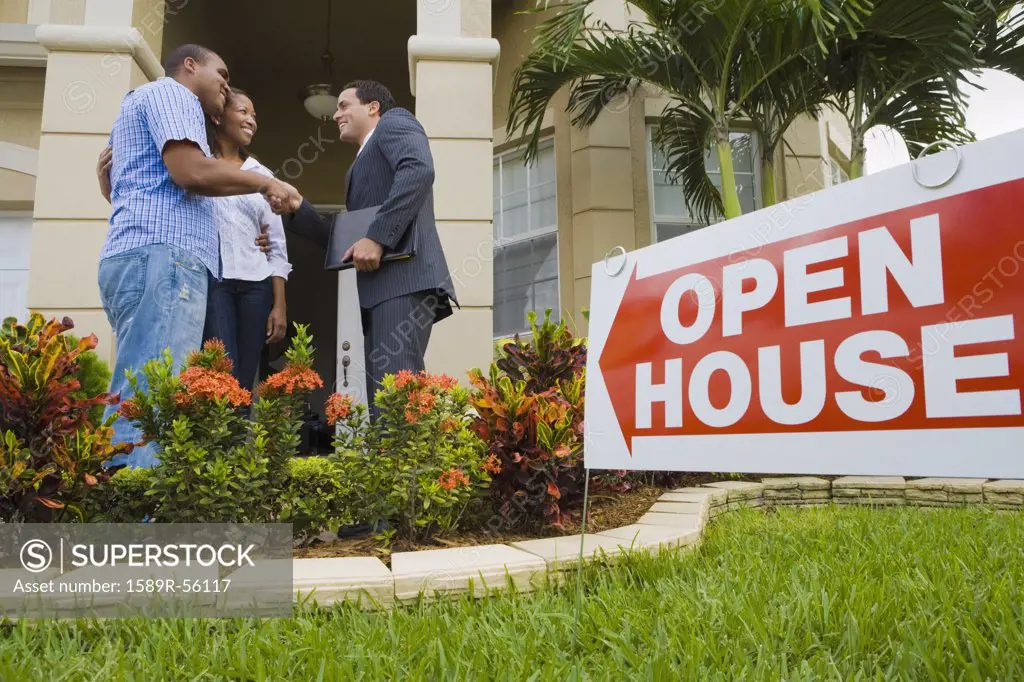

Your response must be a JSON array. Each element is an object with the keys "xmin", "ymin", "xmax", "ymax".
[{"xmin": 598, "ymin": 180, "xmax": 1024, "ymax": 454}]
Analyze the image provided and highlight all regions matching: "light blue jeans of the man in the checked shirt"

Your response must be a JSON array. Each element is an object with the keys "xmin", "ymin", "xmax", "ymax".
[{"xmin": 99, "ymin": 244, "xmax": 208, "ymax": 468}]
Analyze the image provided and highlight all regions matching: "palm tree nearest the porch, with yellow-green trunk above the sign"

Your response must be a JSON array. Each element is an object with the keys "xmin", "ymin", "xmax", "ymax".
[{"xmin": 507, "ymin": 0, "xmax": 861, "ymax": 221}]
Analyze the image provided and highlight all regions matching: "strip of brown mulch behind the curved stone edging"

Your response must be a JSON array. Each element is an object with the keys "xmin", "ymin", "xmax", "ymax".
[{"xmin": 292, "ymin": 473, "xmax": 722, "ymax": 567}]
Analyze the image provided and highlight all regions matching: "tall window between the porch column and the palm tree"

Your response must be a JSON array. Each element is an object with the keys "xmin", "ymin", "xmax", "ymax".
[{"xmin": 494, "ymin": 140, "xmax": 559, "ymax": 338}]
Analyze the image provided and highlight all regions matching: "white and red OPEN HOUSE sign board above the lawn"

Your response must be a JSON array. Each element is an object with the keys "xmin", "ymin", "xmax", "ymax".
[{"xmin": 586, "ymin": 131, "xmax": 1024, "ymax": 478}]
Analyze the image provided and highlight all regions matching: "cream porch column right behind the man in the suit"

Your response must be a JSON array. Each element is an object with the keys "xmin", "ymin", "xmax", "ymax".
[{"xmin": 409, "ymin": 0, "xmax": 500, "ymax": 382}]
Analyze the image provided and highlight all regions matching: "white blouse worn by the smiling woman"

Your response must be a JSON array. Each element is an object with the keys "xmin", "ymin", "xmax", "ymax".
[{"xmin": 213, "ymin": 157, "xmax": 292, "ymax": 282}]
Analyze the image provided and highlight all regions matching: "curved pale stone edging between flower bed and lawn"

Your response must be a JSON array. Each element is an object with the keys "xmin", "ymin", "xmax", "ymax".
[{"xmin": 0, "ymin": 476, "xmax": 1024, "ymax": 609}]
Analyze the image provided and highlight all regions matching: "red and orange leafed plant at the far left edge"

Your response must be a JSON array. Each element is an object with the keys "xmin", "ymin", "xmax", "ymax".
[{"xmin": 0, "ymin": 313, "xmax": 130, "ymax": 522}]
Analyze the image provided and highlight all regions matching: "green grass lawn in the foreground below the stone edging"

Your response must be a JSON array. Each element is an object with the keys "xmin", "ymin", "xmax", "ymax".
[{"xmin": 0, "ymin": 501, "xmax": 1024, "ymax": 681}]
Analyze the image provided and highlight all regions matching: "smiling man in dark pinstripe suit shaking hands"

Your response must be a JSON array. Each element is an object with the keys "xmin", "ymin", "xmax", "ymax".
[{"xmin": 288, "ymin": 76, "xmax": 458, "ymax": 417}]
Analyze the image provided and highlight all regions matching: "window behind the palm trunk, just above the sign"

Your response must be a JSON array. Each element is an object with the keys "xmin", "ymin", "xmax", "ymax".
[{"xmin": 647, "ymin": 126, "xmax": 759, "ymax": 242}]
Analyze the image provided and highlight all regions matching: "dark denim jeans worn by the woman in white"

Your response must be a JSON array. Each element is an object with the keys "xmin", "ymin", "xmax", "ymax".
[{"xmin": 203, "ymin": 278, "xmax": 273, "ymax": 390}]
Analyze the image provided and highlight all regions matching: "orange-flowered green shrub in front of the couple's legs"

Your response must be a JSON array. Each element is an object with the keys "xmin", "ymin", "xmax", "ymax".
[{"xmin": 120, "ymin": 326, "xmax": 322, "ymax": 523}]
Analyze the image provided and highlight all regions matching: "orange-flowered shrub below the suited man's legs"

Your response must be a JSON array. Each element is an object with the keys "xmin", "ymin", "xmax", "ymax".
[{"xmin": 326, "ymin": 372, "xmax": 489, "ymax": 542}]
